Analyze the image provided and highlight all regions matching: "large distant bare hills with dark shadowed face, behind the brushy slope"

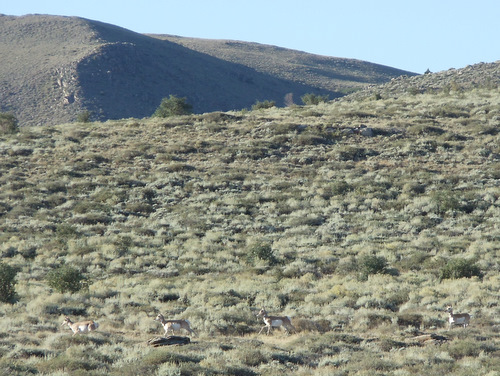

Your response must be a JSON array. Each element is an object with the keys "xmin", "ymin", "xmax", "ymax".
[{"xmin": 0, "ymin": 15, "xmax": 418, "ymax": 125}]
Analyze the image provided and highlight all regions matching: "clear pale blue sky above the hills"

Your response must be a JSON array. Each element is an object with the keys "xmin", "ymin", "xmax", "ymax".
[{"xmin": 0, "ymin": 0, "xmax": 500, "ymax": 73}]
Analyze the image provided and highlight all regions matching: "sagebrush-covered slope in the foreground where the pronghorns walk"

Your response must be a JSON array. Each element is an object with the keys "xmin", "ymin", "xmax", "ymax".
[{"xmin": 0, "ymin": 88, "xmax": 500, "ymax": 376}]
